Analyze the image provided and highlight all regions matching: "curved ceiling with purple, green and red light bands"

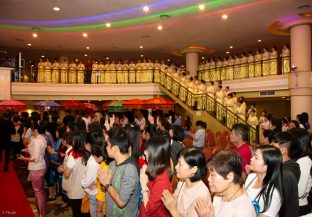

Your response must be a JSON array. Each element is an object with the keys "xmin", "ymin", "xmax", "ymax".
[{"xmin": 0, "ymin": 0, "xmax": 312, "ymax": 61}]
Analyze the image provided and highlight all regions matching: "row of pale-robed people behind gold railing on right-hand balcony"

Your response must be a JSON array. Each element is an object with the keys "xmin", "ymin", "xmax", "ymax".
[{"xmin": 199, "ymin": 45, "xmax": 291, "ymax": 81}]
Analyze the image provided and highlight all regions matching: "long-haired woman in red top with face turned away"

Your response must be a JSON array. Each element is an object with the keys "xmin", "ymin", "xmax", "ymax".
[{"xmin": 139, "ymin": 136, "xmax": 171, "ymax": 217}]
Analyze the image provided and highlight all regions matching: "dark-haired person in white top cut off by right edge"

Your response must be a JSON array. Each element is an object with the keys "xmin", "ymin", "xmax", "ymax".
[{"xmin": 289, "ymin": 128, "xmax": 312, "ymax": 216}]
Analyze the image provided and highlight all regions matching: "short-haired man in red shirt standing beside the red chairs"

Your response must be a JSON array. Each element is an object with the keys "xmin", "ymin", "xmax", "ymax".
[{"xmin": 230, "ymin": 124, "xmax": 251, "ymax": 180}]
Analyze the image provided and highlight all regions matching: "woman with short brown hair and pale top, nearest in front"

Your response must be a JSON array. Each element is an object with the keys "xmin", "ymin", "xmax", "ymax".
[{"xmin": 195, "ymin": 150, "xmax": 256, "ymax": 217}]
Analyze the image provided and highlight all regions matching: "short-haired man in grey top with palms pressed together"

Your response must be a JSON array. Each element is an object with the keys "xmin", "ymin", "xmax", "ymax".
[{"xmin": 98, "ymin": 128, "xmax": 139, "ymax": 217}]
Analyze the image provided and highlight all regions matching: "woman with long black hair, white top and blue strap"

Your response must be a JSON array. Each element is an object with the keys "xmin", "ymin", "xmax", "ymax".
[{"xmin": 245, "ymin": 145, "xmax": 283, "ymax": 217}]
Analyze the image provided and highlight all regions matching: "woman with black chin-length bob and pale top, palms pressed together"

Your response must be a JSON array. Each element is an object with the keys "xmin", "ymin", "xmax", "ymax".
[{"xmin": 162, "ymin": 147, "xmax": 211, "ymax": 217}]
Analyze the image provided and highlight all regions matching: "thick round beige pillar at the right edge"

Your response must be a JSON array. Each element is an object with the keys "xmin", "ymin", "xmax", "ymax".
[{"xmin": 288, "ymin": 24, "xmax": 312, "ymax": 119}]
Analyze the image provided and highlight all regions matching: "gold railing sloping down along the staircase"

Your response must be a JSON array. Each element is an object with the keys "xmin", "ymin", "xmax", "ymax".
[{"xmin": 159, "ymin": 71, "xmax": 257, "ymax": 144}]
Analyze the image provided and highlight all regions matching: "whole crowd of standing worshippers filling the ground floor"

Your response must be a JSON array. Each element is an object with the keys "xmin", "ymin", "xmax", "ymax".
[{"xmin": 0, "ymin": 107, "xmax": 312, "ymax": 217}]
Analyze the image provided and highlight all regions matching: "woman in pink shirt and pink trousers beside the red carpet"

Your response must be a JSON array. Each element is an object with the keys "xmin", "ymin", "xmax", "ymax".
[{"xmin": 19, "ymin": 123, "xmax": 47, "ymax": 217}]
